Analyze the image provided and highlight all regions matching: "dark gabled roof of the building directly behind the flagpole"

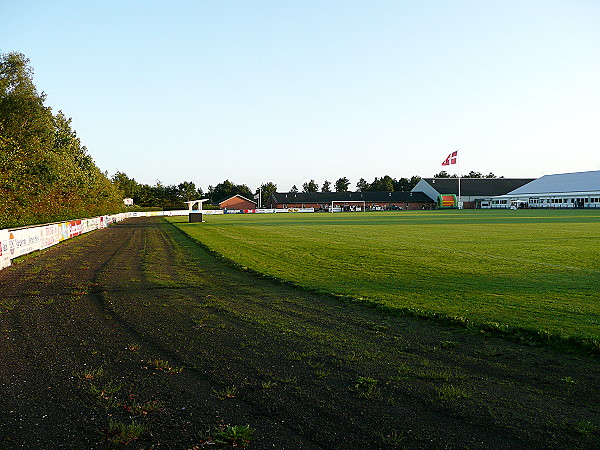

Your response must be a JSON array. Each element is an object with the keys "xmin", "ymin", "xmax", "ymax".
[{"xmin": 422, "ymin": 178, "xmax": 534, "ymax": 197}]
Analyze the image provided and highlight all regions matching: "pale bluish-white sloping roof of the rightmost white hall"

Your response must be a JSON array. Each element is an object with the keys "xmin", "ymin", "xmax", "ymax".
[{"xmin": 509, "ymin": 170, "xmax": 600, "ymax": 195}]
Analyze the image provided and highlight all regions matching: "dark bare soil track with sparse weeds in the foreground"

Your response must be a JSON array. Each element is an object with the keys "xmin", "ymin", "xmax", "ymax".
[{"xmin": 0, "ymin": 219, "xmax": 600, "ymax": 449}]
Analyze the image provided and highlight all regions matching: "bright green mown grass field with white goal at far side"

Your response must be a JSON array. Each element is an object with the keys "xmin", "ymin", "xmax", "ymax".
[{"xmin": 169, "ymin": 210, "xmax": 600, "ymax": 346}]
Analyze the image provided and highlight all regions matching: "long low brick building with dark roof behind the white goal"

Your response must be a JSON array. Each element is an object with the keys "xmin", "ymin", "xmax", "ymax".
[{"xmin": 266, "ymin": 191, "xmax": 435, "ymax": 211}]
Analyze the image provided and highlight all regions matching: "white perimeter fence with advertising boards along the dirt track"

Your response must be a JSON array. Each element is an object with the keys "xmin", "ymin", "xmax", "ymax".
[{"xmin": 0, "ymin": 208, "xmax": 314, "ymax": 269}]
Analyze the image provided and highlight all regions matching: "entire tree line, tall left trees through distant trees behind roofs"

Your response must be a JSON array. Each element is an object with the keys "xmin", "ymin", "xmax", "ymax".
[{"xmin": 0, "ymin": 52, "xmax": 504, "ymax": 228}]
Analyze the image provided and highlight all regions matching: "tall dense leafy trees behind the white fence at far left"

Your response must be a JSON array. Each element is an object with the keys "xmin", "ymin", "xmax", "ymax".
[{"xmin": 0, "ymin": 52, "xmax": 122, "ymax": 228}]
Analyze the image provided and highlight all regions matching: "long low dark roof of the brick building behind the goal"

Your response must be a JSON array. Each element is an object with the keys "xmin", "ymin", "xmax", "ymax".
[{"xmin": 271, "ymin": 191, "xmax": 431, "ymax": 204}]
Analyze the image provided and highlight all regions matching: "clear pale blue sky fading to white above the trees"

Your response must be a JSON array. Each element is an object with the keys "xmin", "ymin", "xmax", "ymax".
[{"xmin": 0, "ymin": 0, "xmax": 600, "ymax": 191}]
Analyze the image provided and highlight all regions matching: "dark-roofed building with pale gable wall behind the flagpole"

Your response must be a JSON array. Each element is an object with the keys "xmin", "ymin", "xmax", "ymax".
[{"xmin": 412, "ymin": 178, "xmax": 534, "ymax": 209}]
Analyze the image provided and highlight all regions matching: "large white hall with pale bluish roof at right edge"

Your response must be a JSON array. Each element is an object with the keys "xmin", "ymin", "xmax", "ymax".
[{"xmin": 489, "ymin": 170, "xmax": 600, "ymax": 208}]
